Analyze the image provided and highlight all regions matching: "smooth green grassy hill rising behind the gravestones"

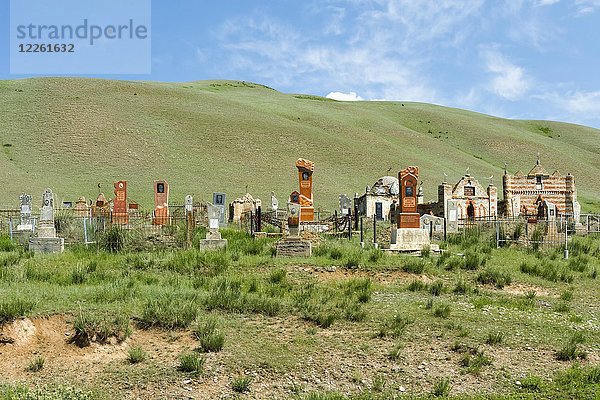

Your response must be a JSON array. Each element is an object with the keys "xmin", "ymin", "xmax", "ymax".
[{"xmin": 0, "ymin": 78, "xmax": 600, "ymax": 211}]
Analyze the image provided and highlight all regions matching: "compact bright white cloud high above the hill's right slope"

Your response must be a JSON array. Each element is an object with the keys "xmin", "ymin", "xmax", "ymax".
[{"xmin": 483, "ymin": 49, "xmax": 530, "ymax": 101}]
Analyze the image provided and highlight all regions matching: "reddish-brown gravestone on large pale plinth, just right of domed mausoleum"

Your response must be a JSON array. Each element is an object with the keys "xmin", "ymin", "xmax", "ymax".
[{"xmin": 390, "ymin": 167, "xmax": 431, "ymax": 251}]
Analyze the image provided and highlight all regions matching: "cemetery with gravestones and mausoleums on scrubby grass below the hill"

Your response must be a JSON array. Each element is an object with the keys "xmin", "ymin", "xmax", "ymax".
[{"xmin": 0, "ymin": 152, "xmax": 600, "ymax": 398}]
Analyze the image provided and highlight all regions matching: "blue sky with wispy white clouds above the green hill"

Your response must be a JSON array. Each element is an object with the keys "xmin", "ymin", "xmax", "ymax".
[{"xmin": 0, "ymin": 0, "xmax": 600, "ymax": 127}]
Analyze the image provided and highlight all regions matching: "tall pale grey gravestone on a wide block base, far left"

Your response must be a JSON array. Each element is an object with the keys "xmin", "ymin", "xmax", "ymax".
[{"xmin": 29, "ymin": 189, "xmax": 65, "ymax": 253}]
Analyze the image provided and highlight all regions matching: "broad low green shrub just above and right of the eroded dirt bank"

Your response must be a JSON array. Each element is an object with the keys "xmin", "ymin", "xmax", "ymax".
[{"xmin": 139, "ymin": 293, "xmax": 198, "ymax": 329}]
